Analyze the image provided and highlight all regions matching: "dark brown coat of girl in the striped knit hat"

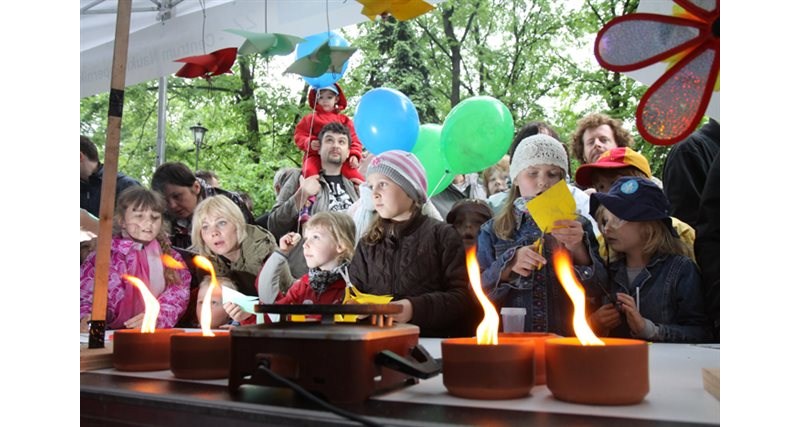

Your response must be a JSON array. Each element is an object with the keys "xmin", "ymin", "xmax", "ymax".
[{"xmin": 350, "ymin": 215, "xmax": 479, "ymax": 337}]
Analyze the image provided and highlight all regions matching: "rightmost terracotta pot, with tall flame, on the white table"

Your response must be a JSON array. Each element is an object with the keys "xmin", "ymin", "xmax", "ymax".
[{"xmin": 545, "ymin": 338, "xmax": 650, "ymax": 405}]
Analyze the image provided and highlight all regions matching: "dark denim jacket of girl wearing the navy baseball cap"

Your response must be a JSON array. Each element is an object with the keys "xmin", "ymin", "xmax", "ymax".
[{"xmin": 608, "ymin": 255, "xmax": 710, "ymax": 342}]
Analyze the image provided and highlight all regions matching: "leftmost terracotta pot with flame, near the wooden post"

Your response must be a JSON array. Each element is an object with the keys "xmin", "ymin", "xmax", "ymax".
[{"xmin": 111, "ymin": 329, "xmax": 183, "ymax": 371}]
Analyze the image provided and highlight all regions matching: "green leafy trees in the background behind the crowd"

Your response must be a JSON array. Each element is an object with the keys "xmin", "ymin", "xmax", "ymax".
[{"xmin": 81, "ymin": 0, "xmax": 684, "ymax": 209}]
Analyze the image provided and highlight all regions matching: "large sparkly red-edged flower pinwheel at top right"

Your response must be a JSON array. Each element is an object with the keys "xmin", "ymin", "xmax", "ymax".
[{"xmin": 594, "ymin": 0, "xmax": 720, "ymax": 145}]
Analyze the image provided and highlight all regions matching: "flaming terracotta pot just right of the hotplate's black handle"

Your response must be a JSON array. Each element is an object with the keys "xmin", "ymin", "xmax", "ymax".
[{"xmin": 442, "ymin": 338, "xmax": 535, "ymax": 400}]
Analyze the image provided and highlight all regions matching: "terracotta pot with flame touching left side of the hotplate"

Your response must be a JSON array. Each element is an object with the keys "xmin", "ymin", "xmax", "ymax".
[{"xmin": 169, "ymin": 332, "xmax": 231, "ymax": 380}]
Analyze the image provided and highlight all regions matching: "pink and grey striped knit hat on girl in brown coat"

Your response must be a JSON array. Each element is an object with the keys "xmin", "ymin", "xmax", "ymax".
[{"xmin": 367, "ymin": 150, "xmax": 428, "ymax": 205}]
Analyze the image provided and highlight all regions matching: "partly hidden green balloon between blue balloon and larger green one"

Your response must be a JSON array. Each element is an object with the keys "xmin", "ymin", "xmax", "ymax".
[{"xmin": 411, "ymin": 123, "xmax": 456, "ymax": 197}]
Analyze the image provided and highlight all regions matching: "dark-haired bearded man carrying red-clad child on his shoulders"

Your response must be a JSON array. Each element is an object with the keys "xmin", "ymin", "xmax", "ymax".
[{"xmin": 265, "ymin": 122, "xmax": 358, "ymax": 277}]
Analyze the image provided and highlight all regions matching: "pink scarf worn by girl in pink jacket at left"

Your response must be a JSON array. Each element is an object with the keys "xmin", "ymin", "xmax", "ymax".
[{"xmin": 109, "ymin": 240, "xmax": 166, "ymax": 329}]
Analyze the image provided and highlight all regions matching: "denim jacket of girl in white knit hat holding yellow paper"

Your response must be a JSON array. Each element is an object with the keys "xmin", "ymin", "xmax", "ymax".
[{"xmin": 478, "ymin": 215, "xmax": 606, "ymax": 336}]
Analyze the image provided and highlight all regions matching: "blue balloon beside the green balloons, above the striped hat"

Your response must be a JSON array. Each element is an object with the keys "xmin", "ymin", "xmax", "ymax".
[{"xmin": 353, "ymin": 87, "xmax": 419, "ymax": 154}]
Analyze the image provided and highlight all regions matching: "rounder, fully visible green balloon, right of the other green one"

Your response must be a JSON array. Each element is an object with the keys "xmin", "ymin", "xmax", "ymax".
[{"xmin": 442, "ymin": 96, "xmax": 514, "ymax": 174}]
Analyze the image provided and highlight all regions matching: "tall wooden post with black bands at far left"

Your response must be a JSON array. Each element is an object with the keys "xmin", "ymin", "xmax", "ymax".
[{"xmin": 89, "ymin": 0, "xmax": 131, "ymax": 348}]
